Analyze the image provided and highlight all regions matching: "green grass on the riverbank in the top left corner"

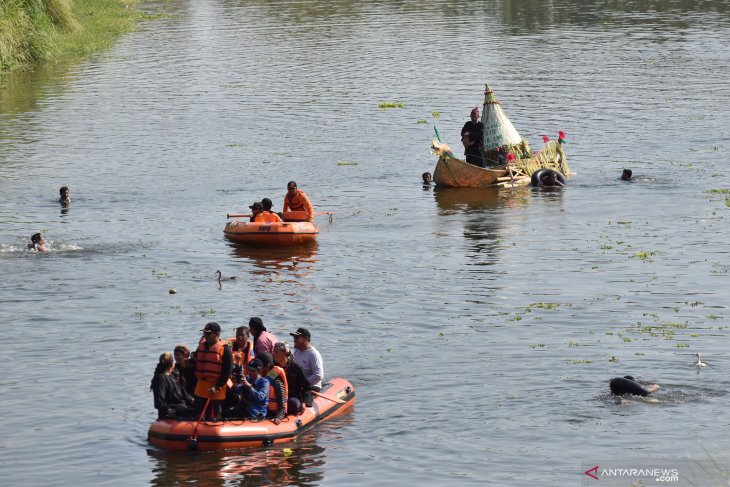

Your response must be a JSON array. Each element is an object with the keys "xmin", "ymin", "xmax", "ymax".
[{"xmin": 0, "ymin": 0, "xmax": 148, "ymax": 71}]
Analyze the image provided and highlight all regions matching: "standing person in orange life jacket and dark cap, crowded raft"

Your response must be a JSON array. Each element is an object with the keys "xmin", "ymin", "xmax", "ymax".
[{"xmin": 195, "ymin": 322, "xmax": 233, "ymax": 417}]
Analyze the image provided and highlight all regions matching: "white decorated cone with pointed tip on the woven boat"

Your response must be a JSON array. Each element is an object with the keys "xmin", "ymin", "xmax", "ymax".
[{"xmin": 482, "ymin": 83, "xmax": 532, "ymax": 166}]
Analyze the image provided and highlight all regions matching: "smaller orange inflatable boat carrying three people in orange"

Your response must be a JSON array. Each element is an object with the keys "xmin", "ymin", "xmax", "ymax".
[{"xmin": 223, "ymin": 211, "xmax": 319, "ymax": 246}]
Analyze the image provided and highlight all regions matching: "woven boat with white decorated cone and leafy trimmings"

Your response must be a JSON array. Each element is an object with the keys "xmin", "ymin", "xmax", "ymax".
[{"xmin": 431, "ymin": 84, "xmax": 570, "ymax": 188}]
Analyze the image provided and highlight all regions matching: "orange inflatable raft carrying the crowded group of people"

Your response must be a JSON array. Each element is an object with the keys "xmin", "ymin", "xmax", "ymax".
[{"xmin": 147, "ymin": 378, "xmax": 355, "ymax": 451}]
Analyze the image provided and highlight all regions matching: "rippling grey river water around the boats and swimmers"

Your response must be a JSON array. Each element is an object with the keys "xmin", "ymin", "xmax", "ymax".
[{"xmin": 0, "ymin": 0, "xmax": 730, "ymax": 486}]
